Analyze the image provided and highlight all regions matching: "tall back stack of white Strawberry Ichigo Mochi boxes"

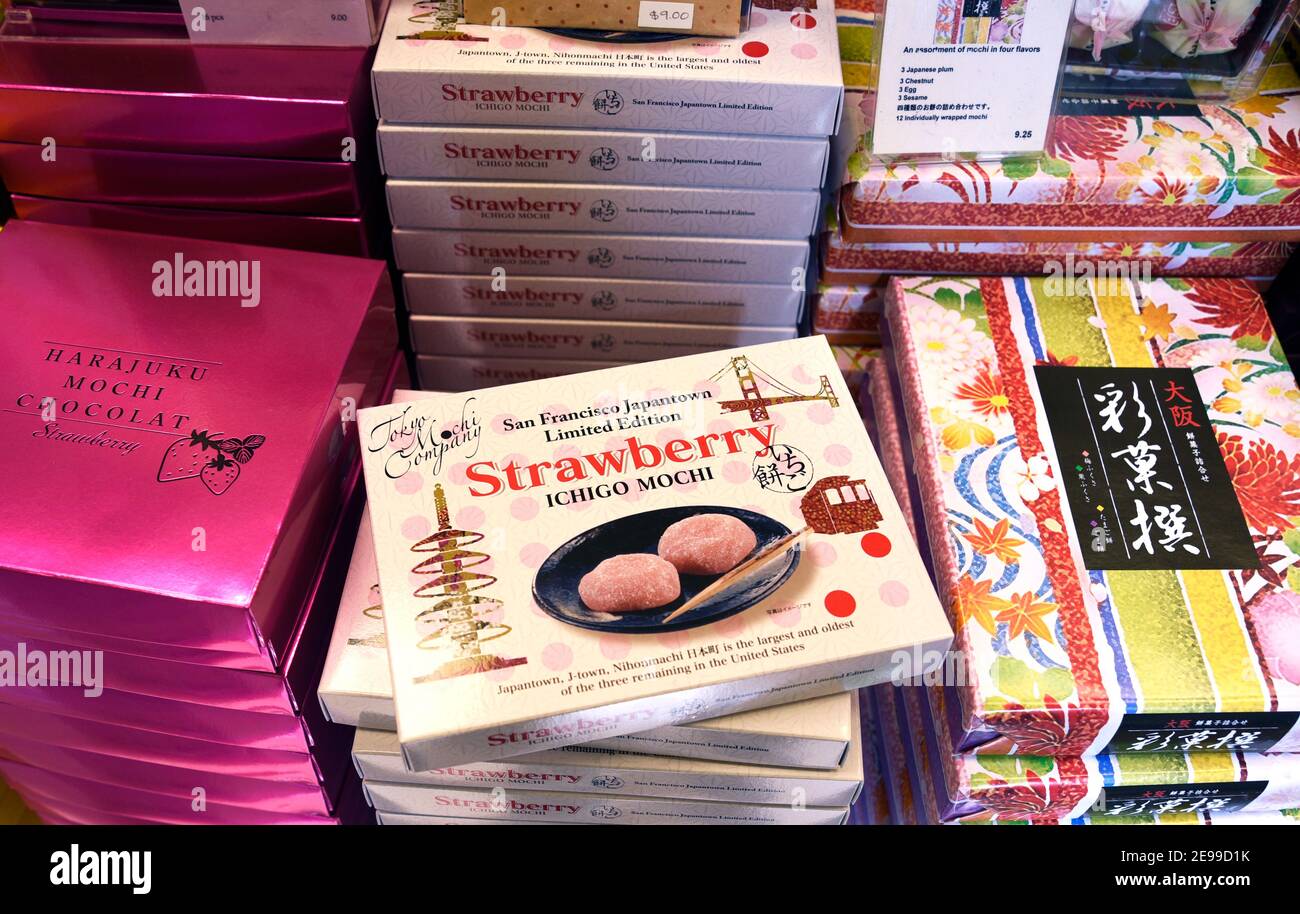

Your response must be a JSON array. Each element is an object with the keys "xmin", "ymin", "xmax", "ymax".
[{"xmin": 373, "ymin": 0, "xmax": 844, "ymax": 390}]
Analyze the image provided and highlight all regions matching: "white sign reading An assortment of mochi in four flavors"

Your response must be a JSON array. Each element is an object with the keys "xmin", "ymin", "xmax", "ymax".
[{"xmin": 872, "ymin": 0, "xmax": 1073, "ymax": 156}]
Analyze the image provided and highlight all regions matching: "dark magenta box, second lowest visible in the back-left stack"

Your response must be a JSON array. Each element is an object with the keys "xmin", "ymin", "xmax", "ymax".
[{"xmin": 0, "ymin": 142, "xmax": 369, "ymax": 216}]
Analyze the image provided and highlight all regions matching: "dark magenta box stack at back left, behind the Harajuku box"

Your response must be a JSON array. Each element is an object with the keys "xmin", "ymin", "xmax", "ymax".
[{"xmin": 0, "ymin": 6, "xmax": 387, "ymax": 256}]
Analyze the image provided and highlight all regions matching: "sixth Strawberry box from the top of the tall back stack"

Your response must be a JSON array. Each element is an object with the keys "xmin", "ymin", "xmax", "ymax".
[{"xmin": 411, "ymin": 315, "xmax": 798, "ymax": 363}]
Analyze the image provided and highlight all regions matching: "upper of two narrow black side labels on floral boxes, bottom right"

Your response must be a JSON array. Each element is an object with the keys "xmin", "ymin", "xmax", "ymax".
[{"xmin": 1106, "ymin": 711, "xmax": 1300, "ymax": 753}]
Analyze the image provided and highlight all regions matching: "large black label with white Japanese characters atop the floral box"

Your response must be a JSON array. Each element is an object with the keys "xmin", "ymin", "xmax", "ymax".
[{"xmin": 1035, "ymin": 365, "xmax": 1260, "ymax": 571}]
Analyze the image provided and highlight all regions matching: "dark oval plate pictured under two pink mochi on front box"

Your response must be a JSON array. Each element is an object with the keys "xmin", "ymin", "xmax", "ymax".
[{"xmin": 533, "ymin": 504, "xmax": 801, "ymax": 634}]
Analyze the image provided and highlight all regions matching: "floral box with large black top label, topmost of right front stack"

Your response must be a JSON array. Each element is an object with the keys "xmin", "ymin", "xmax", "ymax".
[{"xmin": 887, "ymin": 278, "xmax": 1300, "ymax": 755}]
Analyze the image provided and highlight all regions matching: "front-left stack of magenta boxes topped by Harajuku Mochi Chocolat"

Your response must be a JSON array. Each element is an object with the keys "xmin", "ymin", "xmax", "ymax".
[{"xmin": 0, "ymin": 220, "xmax": 399, "ymax": 823}]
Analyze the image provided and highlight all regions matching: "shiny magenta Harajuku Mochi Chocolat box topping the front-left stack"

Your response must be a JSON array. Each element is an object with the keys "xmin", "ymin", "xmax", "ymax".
[{"xmin": 0, "ymin": 221, "xmax": 395, "ymax": 671}]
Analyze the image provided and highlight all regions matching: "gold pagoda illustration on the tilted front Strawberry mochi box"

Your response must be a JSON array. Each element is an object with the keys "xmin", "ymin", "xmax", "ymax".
[{"xmin": 411, "ymin": 485, "xmax": 528, "ymax": 683}]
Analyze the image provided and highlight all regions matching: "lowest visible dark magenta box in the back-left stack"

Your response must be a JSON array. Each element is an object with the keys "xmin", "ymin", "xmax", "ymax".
[{"xmin": 13, "ymin": 194, "xmax": 387, "ymax": 257}]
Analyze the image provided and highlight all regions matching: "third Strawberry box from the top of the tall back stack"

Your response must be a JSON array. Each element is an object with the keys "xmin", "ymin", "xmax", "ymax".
[{"xmin": 387, "ymin": 178, "xmax": 822, "ymax": 239}]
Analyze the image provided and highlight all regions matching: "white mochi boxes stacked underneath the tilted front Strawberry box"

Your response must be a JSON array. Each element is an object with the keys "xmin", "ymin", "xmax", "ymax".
[{"xmin": 320, "ymin": 390, "xmax": 884, "ymax": 824}]
